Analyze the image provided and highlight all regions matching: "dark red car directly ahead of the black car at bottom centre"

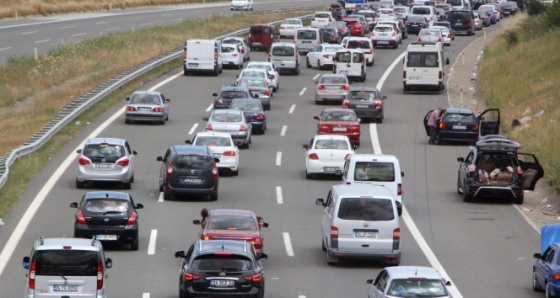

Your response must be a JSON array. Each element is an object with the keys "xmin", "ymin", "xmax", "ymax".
[{"xmin": 193, "ymin": 209, "xmax": 268, "ymax": 252}]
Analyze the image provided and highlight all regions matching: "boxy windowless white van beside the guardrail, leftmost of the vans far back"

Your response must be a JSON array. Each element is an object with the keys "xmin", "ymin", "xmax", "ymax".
[{"xmin": 183, "ymin": 39, "xmax": 222, "ymax": 76}]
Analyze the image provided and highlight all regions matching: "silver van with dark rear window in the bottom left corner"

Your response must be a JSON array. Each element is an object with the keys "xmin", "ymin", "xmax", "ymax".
[{"xmin": 23, "ymin": 238, "xmax": 113, "ymax": 298}]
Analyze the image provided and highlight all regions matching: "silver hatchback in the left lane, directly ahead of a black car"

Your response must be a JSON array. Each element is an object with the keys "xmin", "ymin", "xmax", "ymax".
[{"xmin": 76, "ymin": 138, "xmax": 137, "ymax": 189}]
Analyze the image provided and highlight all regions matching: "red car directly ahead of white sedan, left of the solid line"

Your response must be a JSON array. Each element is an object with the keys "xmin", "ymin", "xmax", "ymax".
[{"xmin": 313, "ymin": 108, "xmax": 360, "ymax": 146}]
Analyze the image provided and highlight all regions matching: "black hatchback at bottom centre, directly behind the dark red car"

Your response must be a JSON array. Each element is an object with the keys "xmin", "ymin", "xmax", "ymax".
[{"xmin": 175, "ymin": 240, "xmax": 268, "ymax": 298}]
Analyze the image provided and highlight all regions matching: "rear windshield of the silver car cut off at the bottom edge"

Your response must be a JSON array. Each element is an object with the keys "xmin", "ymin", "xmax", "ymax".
[{"xmin": 387, "ymin": 279, "xmax": 449, "ymax": 297}]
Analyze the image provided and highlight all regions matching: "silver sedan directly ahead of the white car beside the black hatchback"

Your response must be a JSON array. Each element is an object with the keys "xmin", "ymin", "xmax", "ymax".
[{"xmin": 202, "ymin": 109, "xmax": 252, "ymax": 149}]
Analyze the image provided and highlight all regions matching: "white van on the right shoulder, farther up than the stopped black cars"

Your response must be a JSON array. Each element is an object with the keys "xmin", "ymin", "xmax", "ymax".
[{"xmin": 403, "ymin": 42, "xmax": 449, "ymax": 93}]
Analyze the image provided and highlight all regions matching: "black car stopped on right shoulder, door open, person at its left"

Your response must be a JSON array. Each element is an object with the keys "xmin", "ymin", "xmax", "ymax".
[{"xmin": 424, "ymin": 108, "xmax": 500, "ymax": 145}]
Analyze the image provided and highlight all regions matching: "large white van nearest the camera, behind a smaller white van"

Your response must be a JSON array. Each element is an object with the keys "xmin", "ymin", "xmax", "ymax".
[{"xmin": 315, "ymin": 184, "xmax": 401, "ymax": 265}]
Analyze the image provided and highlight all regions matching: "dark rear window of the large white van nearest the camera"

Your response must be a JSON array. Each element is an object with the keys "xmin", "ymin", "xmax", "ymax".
[{"xmin": 338, "ymin": 197, "xmax": 395, "ymax": 221}]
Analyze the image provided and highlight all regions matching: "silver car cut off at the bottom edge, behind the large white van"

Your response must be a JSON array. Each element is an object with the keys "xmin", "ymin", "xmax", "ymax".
[{"xmin": 367, "ymin": 266, "xmax": 451, "ymax": 298}]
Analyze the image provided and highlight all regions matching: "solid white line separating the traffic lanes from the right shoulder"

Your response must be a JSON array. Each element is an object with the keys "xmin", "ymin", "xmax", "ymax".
[{"xmin": 376, "ymin": 52, "xmax": 463, "ymax": 298}]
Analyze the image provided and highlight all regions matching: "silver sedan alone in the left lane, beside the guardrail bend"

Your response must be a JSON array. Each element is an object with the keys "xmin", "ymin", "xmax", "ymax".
[{"xmin": 124, "ymin": 91, "xmax": 171, "ymax": 124}]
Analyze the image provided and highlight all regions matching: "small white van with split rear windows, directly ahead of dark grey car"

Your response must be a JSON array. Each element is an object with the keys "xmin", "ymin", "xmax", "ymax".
[{"xmin": 333, "ymin": 49, "xmax": 366, "ymax": 82}]
